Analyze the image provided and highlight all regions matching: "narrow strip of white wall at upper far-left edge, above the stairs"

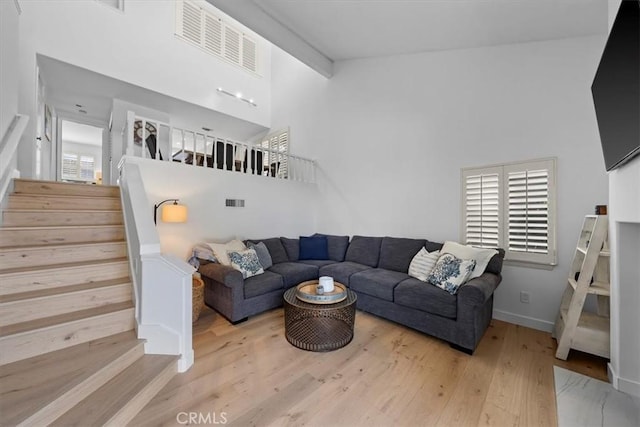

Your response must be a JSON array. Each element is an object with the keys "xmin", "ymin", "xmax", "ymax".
[{"xmin": 0, "ymin": 1, "xmax": 20, "ymax": 138}]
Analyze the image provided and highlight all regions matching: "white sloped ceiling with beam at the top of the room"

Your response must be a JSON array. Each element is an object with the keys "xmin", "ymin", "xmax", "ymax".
[{"xmin": 208, "ymin": 0, "xmax": 607, "ymax": 74}]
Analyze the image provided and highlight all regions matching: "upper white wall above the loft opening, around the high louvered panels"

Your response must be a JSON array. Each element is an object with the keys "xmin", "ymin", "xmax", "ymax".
[{"xmin": 15, "ymin": 0, "xmax": 271, "ymax": 178}]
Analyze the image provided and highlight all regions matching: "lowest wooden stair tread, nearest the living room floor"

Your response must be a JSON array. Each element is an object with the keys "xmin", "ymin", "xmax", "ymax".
[{"xmin": 52, "ymin": 354, "xmax": 178, "ymax": 426}]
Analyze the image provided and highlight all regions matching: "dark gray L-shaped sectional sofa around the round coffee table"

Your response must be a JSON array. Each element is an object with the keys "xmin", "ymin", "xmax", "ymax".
[{"xmin": 199, "ymin": 235, "xmax": 504, "ymax": 354}]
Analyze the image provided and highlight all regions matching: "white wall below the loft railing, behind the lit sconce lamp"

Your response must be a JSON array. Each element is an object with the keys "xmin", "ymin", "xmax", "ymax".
[{"xmin": 132, "ymin": 159, "xmax": 318, "ymax": 259}]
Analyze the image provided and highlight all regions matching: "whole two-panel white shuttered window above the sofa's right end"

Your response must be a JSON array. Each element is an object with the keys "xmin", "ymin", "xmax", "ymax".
[{"xmin": 462, "ymin": 159, "xmax": 556, "ymax": 265}]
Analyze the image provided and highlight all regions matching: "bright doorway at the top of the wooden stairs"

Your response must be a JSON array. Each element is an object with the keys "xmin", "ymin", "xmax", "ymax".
[{"xmin": 56, "ymin": 119, "xmax": 105, "ymax": 185}]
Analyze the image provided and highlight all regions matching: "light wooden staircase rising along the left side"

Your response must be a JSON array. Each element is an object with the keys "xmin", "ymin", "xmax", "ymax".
[{"xmin": 0, "ymin": 180, "xmax": 178, "ymax": 426}]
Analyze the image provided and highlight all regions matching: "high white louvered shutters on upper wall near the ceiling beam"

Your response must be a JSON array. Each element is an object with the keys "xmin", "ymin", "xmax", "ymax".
[{"xmin": 175, "ymin": 0, "xmax": 258, "ymax": 73}]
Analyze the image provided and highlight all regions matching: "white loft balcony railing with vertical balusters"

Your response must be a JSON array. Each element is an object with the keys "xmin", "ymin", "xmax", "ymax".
[{"xmin": 123, "ymin": 111, "xmax": 316, "ymax": 183}]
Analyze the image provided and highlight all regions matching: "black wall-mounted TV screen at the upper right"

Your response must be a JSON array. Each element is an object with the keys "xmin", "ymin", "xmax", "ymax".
[{"xmin": 591, "ymin": 0, "xmax": 640, "ymax": 171}]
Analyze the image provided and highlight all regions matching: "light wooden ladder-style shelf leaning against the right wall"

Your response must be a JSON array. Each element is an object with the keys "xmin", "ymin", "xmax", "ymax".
[{"xmin": 554, "ymin": 215, "xmax": 610, "ymax": 360}]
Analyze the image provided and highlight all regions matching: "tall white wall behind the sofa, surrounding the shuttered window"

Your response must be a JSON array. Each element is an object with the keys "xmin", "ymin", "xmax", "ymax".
[{"xmin": 272, "ymin": 36, "xmax": 608, "ymax": 330}]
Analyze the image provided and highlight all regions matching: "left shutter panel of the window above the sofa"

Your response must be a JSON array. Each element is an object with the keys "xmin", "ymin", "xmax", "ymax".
[{"xmin": 463, "ymin": 169, "xmax": 501, "ymax": 248}]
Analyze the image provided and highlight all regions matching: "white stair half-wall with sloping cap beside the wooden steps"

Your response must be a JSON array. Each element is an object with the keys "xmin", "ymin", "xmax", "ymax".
[{"xmin": 118, "ymin": 156, "xmax": 195, "ymax": 372}]
